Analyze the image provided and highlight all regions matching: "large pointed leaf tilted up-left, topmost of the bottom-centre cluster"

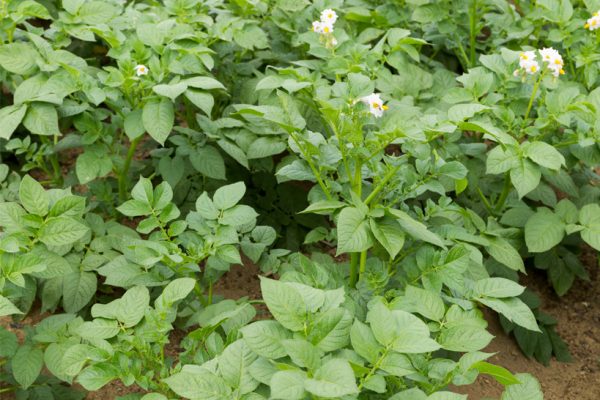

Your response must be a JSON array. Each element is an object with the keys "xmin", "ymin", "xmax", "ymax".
[{"xmin": 260, "ymin": 277, "xmax": 306, "ymax": 331}]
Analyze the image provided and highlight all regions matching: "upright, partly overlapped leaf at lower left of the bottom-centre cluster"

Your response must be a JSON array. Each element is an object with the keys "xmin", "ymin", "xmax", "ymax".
[{"xmin": 219, "ymin": 339, "xmax": 259, "ymax": 394}]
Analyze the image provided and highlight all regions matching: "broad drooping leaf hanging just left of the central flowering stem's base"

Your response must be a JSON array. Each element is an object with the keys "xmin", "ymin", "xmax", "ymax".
[{"xmin": 336, "ymin": 207, "xmax": 373, "ymax": 255}]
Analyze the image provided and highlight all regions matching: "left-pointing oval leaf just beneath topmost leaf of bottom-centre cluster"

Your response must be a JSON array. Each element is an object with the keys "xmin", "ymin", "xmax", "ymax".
[{"xmin": 240, "ymin": 321, "xmax": 291, "ymax": 360}]
